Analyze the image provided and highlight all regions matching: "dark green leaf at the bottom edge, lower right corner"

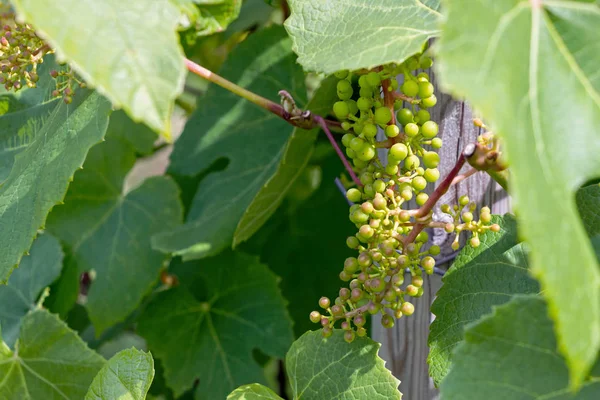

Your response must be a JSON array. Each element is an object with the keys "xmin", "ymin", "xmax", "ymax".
[{"xmin": 441, "ymin": 295, "xmax": 600, "ymax": 400}]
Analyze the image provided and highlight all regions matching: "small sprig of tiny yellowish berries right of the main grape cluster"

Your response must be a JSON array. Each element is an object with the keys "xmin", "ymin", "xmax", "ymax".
[{"xmin": 441, "ymin": 196, "xmax": 500, "ymax": 250}]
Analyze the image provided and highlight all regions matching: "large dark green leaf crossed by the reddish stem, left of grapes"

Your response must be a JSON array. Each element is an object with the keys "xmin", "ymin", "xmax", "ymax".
[{"xmin": 153, "ymin": 27, "xmax": 306, "ymax": 260}]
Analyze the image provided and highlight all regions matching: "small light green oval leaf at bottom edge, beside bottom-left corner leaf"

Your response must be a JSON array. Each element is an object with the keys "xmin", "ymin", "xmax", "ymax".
[{"xmin": 85, "ymin": 348, "xmax": 154, "ymax": 400}]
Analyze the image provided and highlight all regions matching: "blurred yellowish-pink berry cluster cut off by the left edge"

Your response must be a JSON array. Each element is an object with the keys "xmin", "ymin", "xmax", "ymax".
[{"xmin": 0, "ymin": 10, "xmax": 52, "ymax": 91}]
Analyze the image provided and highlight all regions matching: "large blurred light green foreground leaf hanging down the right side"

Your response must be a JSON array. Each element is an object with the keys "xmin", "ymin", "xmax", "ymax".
[{"xmin": 438, "ymin": 0, "xmax": 600, "ymax": 388}]
